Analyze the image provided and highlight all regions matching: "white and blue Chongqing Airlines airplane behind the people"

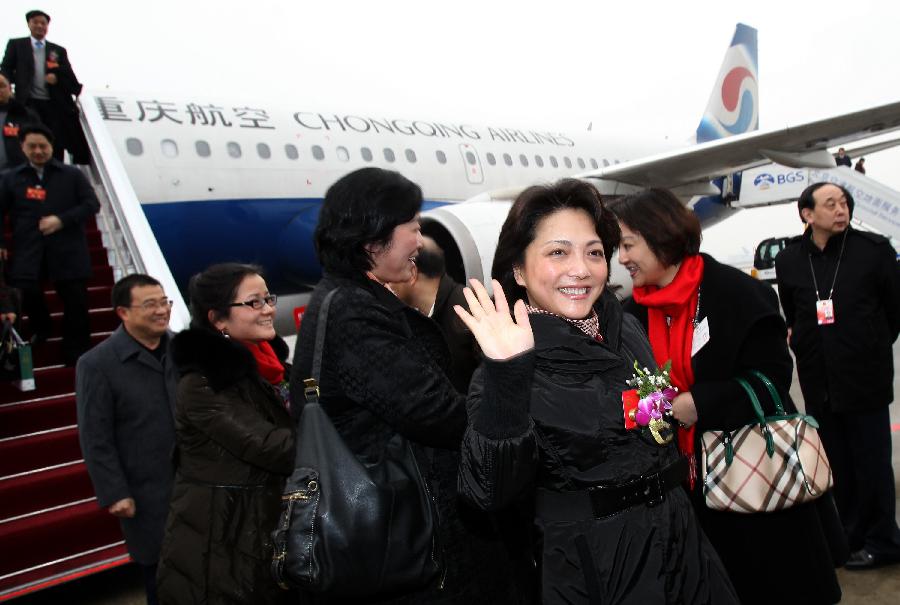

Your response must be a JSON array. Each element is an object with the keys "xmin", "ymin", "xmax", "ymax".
[{"xmin": 81, "ymin": 24, "xmax": 900, "ymax": 302}]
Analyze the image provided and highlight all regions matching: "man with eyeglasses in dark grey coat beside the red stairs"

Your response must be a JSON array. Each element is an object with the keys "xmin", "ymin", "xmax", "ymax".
[{"xmin": 75, "ymin": 274, "xmax": 177, "ymax": 604}]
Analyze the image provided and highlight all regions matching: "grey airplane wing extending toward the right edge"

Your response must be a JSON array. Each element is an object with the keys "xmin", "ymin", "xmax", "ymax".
[{"xmin": 576, "ymin": 102, "xmax": 900, "ymax": 195}]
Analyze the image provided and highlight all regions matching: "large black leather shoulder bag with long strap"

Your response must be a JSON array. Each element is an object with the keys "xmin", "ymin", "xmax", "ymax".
[{"xmin": 272, "ymin": 289, "xmax": 442, "ymax": 597}]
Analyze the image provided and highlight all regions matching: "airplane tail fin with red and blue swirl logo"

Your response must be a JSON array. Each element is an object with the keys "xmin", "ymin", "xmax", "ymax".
[{"xmin": 697, "ymin": 23, "xmax": 759, "ymax": 143}]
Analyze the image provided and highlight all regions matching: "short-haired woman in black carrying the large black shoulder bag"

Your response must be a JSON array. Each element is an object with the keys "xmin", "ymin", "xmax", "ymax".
[{"xmin": 291, "ymin": 168, "xmax": 531, "ymax": 605}]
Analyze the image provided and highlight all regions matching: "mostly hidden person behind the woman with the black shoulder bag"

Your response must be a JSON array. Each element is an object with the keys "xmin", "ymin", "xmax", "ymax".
[{"xmin": 391, "ymin": 237, "xmax": 480, "ymax": 393}]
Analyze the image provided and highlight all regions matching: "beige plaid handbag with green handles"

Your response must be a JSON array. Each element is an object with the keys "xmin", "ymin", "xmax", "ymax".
[{"xmin": 701, "ymin": 371, "xmax": 832, "ymax": 513}]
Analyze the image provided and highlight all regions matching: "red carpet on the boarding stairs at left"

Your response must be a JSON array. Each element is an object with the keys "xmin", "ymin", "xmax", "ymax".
[{"xmin": 0, "ymin": 217, "xmax": 129, "ymax": 601}]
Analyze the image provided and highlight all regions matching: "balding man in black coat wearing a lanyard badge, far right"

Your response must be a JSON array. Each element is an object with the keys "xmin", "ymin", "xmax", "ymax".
[{"xmin": 775, "ymin": 183, "xmax": 900, "ymax": 569}]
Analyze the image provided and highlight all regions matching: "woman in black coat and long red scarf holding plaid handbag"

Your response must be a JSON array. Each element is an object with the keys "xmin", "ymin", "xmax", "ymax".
[{"xmin": 613, "ymin": 189, "xmax": 845, "ymax": 605}]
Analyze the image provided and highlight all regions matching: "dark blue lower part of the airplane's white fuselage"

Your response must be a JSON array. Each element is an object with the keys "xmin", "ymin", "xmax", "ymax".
[{"xmin": 142, "ymin": 198, "xmax": 444, "ymax": 292}]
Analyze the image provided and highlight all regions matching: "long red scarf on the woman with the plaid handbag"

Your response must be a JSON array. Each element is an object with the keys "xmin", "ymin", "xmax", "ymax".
[{"xmin": 634, "ymin": 254, "xmax": 703, "ymax": 489}]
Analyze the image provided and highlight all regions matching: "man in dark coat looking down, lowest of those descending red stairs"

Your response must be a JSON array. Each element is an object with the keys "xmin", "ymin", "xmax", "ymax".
[{"xmin": 0, "ymin": 124, "xmax": 100, "ymax": 366}]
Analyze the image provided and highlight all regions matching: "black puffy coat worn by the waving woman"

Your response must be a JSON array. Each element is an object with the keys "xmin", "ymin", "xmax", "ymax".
[{"xmin": 459, "ymin": 292, "xmax": 737, "ymax": 605}]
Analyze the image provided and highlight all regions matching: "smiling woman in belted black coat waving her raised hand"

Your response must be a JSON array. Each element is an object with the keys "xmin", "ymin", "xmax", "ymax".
[{"xmin": 460, "ymin": 180, "xmax": 737, "ymax": 605}]
